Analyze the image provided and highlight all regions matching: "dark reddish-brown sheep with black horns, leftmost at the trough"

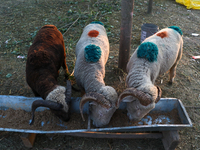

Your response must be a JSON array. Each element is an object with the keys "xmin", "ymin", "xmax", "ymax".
[{"xmin": 26, "ymin": 25, "xmax": 71, "ymax": 125}]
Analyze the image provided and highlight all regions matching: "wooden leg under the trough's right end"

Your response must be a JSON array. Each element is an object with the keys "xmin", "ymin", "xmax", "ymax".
[{"xmin": 162, "ymin": 130, "xmax": 180, "ymax": 150}]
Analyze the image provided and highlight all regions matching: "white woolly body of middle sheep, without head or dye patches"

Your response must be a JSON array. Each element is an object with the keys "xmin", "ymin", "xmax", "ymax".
[{"xmin": 74, "ymin": 24, "xmax": 110, "ymax": 93}]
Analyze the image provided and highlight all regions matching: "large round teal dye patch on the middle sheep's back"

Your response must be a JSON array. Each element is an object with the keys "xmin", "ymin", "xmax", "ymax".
[{"xmin": 84, "ymin": 44, "xmax": 101, "ymax": 62}]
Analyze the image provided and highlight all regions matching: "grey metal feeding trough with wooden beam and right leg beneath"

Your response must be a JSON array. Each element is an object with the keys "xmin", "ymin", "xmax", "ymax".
[{"xmin": 0, "ymin": 95, "xmax": 192, "ymax": 149}]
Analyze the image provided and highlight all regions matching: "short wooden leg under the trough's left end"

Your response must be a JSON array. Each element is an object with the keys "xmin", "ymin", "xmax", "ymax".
[{"xmin": 20, "ymin": 133, "xmax": 36, "ymax": 148}]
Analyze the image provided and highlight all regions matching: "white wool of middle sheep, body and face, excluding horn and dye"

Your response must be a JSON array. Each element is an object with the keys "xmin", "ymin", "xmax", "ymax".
[{"xmin": 74, "ymin": 24, "xmax": 118, "ymax": 127}]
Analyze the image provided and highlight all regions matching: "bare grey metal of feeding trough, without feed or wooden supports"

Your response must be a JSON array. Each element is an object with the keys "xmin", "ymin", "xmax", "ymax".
[{"xmin": 0, "ymin": 95, "xmax": 192, "ymax": 134}]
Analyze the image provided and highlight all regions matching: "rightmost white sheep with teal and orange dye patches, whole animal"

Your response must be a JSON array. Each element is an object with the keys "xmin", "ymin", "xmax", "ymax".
[{"xmin": 117, "ymin": 26, "xmax": 183, "ymax": 121}]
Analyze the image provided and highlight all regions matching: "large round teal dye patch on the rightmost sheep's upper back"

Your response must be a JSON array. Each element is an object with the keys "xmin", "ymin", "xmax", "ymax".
[{"xmin": 137, "ymin": 42, "xmax": 158, "ymax": 62}]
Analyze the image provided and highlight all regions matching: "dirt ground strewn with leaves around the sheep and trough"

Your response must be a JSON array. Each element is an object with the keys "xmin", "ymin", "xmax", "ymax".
[{"xmin": 0, "ymin": 0, "xmax": 200, "ymax": 150}]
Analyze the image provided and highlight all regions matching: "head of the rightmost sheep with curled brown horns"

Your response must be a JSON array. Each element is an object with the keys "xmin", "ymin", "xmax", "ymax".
[{"xmin": 117, "ymin": 86, "xmax": 162, "ymax": 121}]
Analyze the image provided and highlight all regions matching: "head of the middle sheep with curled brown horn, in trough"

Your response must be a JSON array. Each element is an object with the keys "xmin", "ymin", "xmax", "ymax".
[{"xmin": 79, "ymin": 86, "xmax": 118, "ymax": 127}]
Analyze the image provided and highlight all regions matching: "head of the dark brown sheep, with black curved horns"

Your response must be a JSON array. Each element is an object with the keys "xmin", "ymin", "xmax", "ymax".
[{"xmin": 30, "ymin": 80, "xmax": 71, "ymax": 125}]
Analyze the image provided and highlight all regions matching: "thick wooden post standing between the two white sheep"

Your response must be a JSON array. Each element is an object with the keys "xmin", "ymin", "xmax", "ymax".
[{"xmin": 118, "ymin": 0, "xmax": 134, "ymax": 72}]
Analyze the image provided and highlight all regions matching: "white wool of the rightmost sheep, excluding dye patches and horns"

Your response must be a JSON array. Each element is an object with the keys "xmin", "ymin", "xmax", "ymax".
[{"xmin": 123, "ymin": 28, "xmax": 183, "ymax": 120}]
